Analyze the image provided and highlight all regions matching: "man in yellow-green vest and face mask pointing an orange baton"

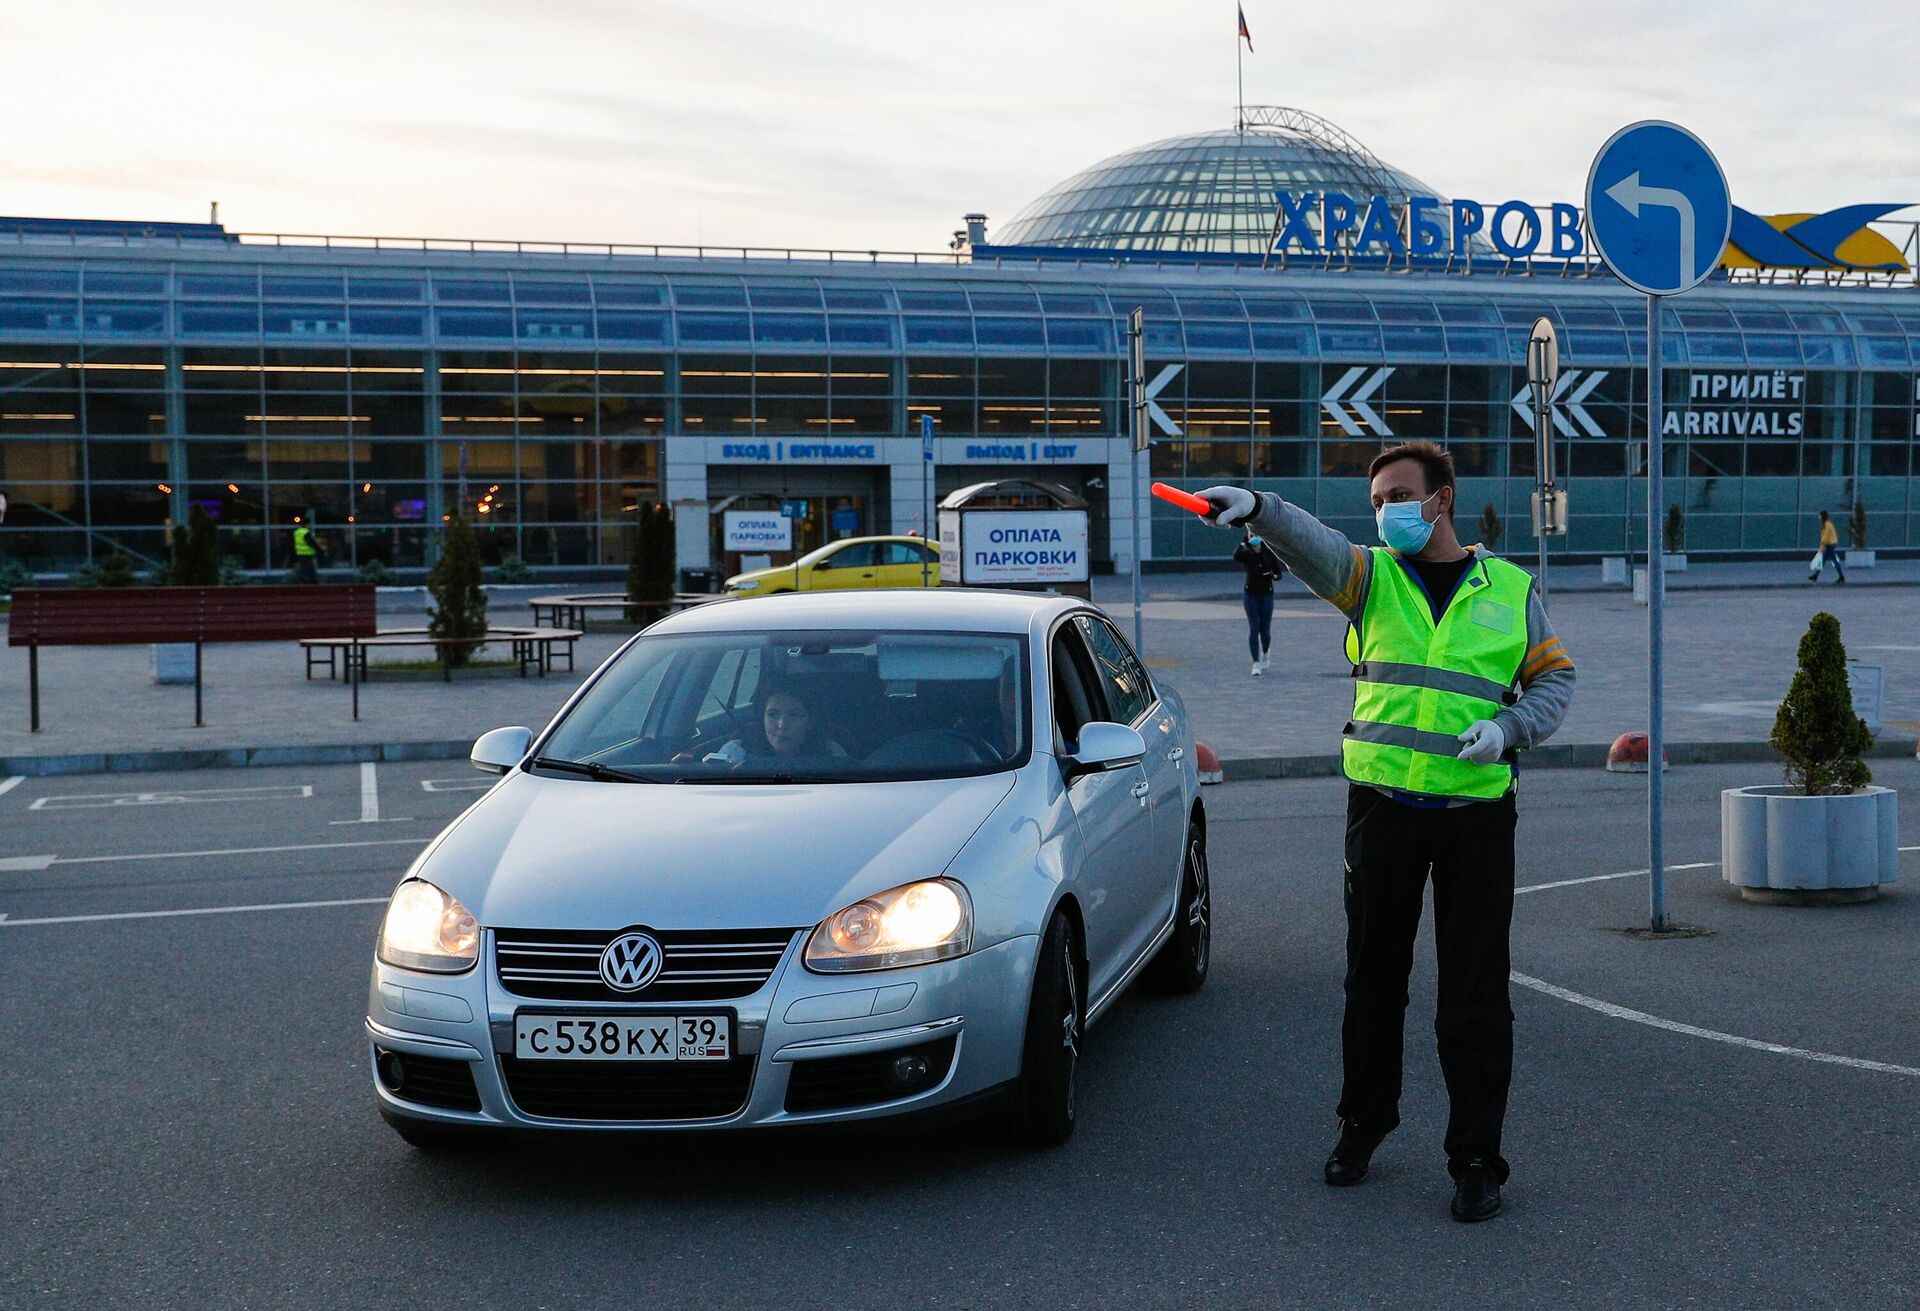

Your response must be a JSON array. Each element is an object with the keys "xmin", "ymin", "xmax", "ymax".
[{"xmin": 1200, "ymin": 441, "xmax": 1572, "ymax": 1221}]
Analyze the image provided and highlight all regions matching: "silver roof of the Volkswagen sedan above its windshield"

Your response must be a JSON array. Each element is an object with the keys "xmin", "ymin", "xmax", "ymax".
[{"xmin": 647, "ymin": 587, "xmax": 1085, "ymax": 635}]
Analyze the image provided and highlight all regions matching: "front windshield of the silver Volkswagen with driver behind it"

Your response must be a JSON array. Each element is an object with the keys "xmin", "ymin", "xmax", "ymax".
[{"xmin": 534, "ymin": 630, "xmax": 1031, "ymax": 783}]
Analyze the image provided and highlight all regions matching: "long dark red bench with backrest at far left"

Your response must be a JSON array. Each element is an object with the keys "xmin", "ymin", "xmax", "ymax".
[{"xmin": 6, "ymin": 584, "xmax": 378, "ymax": 733}]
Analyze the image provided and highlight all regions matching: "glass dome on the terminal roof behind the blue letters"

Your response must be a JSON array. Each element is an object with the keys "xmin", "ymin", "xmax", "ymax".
[{"xmin": 991, "ymin": 106, "xmax": 1438, "ymax": 255}]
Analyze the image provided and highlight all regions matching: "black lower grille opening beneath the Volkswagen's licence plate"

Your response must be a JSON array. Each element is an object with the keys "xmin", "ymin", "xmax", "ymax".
[{"xmin": 499, "ymin": 1054, "xmax": 755, "ymax": 1119}]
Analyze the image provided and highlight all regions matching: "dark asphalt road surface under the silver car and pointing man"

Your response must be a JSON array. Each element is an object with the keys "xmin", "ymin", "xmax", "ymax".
[{"xmin": 0, "ymin": 762, "xmax": 1920, "ymax": 1311}]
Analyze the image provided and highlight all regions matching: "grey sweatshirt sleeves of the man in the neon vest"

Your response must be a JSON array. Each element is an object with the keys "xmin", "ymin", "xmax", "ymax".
[{"xmin": 1254, "ymin": 491, "xmax": 1572, "ymax": 749}]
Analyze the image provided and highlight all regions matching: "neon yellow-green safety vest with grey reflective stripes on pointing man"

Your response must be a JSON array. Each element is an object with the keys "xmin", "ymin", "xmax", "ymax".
[{"xmin": 1340, "ymin": 547, "xmax": 1534, "ymax": 799}]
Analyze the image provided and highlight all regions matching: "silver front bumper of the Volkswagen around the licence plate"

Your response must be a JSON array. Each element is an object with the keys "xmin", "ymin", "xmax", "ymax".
[{"xmin": 367, "ymin": 935, "xmax": 1039, "ymax": 1131}]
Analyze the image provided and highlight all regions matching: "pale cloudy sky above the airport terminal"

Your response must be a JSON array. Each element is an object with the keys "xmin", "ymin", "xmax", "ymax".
[{"xmin": 0, "ymin": 0, "xmax": 1920, "ymax": 251}]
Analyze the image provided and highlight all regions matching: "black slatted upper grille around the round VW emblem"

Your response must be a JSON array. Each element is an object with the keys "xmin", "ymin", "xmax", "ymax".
[{"xmin": 493, "ymin": 929, "xmax": 799, "ymax": 1002}]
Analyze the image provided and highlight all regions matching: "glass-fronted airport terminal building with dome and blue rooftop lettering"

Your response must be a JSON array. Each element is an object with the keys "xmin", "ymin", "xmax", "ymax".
[{"xmin": 0, "ymin": 109, "xmax": 1920, "ymax": 574}]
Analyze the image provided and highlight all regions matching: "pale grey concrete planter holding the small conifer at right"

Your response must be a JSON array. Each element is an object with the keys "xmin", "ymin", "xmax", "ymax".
[{"xmin": 1720, "ymin": 785, "xmax": 1901, "ymax": 906}]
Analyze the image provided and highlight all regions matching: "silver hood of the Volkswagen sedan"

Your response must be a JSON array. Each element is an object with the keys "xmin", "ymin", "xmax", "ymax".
[{"xmin": 415, "ymin": 772, "xmax": 1016, "ymax": 929}]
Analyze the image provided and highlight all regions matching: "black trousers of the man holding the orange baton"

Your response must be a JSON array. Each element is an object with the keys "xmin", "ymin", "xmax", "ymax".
[{"xmin": 1338, "ymin": 783, "xmax": 1517, "ymax": 1182}]
